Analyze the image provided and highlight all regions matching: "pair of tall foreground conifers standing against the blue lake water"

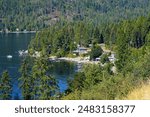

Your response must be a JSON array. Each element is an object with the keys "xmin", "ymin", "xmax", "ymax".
[{"xmin": 19, "ymin": 55, "xmax": 58, "ymax": 100}]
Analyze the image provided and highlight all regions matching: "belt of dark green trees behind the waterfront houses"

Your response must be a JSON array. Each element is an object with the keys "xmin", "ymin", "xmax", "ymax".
[{"xmin": 29, "ymin": 17, "xmax": 150, "ymax": 59}]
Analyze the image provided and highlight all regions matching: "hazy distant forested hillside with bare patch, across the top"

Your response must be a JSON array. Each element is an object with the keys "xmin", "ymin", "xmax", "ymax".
[{"xmin": 0, "ymin": 0, "xmax": 150, "ymax": 31}]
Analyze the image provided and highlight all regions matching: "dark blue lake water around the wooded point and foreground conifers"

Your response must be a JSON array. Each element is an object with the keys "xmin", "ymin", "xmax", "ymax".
[{"xmin": 0, "ymin": 33, "xmax": 77, "ymax": 99}]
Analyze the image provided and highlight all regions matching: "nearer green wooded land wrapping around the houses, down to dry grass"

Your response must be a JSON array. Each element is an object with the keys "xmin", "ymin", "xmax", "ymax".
[{"xmin": 23, "ymin": 14, "xmax": 150, "ymax": 99}]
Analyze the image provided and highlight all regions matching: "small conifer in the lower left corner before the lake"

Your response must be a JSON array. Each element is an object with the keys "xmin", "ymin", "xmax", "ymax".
[{"xmin": 0, "ymin": 71, "xmax": 12, "ymax": 100}]
